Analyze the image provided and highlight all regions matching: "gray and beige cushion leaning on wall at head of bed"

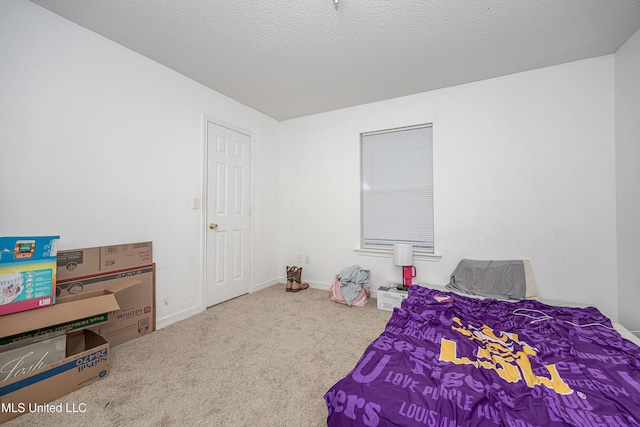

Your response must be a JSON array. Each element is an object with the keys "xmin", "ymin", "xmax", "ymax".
[{"xmin": 446, "ymin": 259, "xmax": 536, "ymax": 300}]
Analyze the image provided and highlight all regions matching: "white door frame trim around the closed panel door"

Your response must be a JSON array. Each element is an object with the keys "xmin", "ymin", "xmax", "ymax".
[{"xmin": 200, "ymin": 114, "xmax": 255, "ymax": 311}]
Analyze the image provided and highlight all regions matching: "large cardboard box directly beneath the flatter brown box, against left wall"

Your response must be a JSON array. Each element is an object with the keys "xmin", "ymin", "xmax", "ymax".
[{"xmin": 58, "ymin": 264, "xmax": 156, "ymax": 347}]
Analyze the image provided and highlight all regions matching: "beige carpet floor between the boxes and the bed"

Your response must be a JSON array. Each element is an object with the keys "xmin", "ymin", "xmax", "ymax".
[{"xmin": 5, "ymin": 285, "xmax": 391, "ymax": 427}]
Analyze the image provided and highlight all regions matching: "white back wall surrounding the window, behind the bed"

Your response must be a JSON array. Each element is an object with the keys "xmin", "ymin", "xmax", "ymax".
[{"xmin": 280, "ymin": 55, "xmax": 618, "ymax": 319}]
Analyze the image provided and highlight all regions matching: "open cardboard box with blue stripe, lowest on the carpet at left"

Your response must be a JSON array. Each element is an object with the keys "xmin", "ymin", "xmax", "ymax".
[{"xmin": 0, "ymin": 330, "xmax": 109, "ymax": 423}]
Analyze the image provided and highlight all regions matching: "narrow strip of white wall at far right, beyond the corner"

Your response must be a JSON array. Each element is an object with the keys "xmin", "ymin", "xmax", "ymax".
[{"xmin": 615, "ymin": 27, "xmax": 640, "ymax": 333}]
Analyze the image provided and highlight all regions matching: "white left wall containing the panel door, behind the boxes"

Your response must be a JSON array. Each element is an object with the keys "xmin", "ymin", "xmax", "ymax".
[{"xmin": 0, "ymin": 0, "xmax": 279, "ymax": 326}]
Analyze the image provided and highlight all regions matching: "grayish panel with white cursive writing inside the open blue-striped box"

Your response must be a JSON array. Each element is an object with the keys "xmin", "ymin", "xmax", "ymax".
[{"xmin": 0, "ymin": 331, "xmax": 67, "ymax": 385}]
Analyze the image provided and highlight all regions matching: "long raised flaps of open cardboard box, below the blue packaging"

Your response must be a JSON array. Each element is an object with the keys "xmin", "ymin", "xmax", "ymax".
[{"xmin": 0, "ymin": 277, "xmax": 141, "ymax": 344}]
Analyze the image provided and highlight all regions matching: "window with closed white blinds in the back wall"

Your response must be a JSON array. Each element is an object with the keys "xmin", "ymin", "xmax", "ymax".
[{"xmin": 360, "ymin": 124, "xmax": 434, "ymax": 253}]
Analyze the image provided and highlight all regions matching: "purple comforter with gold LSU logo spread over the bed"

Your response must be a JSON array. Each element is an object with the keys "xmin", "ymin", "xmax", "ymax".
[{"xmin": 324, "ymin": 286, "xmax": 640, "ymax": 427}]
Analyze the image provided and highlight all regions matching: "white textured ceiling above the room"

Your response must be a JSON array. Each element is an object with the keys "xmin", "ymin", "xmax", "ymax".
[{"xmin": 32, "ymin": 0, "xmax": 640, "ymax": 120}]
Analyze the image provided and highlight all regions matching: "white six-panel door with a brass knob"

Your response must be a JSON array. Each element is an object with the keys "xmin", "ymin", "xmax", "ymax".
[{"xmin": 205, "ymin": 121, "xmax": 251, "ymax": 307}]
